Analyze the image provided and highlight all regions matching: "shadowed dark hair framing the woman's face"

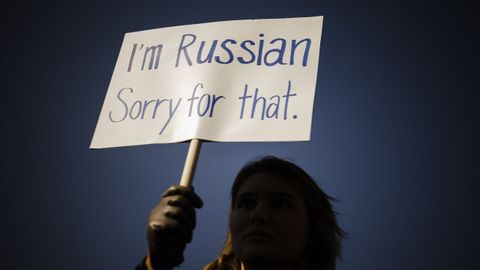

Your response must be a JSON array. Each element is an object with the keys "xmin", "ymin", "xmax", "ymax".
[{"xmin": 204, "ymin": 156, "xmax": 346, "ymax": 270}]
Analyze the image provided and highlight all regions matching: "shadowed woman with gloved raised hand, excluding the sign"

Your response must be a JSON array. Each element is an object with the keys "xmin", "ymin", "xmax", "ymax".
[{"xmin": 137, "ymin": 156, "xmax": 345, "ymax": 270}]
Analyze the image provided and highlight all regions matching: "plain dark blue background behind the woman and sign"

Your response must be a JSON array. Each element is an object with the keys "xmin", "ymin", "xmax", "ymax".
[{"xmin": 0, "ymin": 0, "xmax": 480, "ymax": 270}]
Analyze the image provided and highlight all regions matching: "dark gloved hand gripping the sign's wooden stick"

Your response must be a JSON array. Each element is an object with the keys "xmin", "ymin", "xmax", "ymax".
[{"xmin": 147, "ymin": 185, "xmax": 203, "ymax": 270}]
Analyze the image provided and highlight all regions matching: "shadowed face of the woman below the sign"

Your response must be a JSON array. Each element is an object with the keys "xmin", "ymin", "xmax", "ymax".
[{"xmin": 230, "ymin": 172, "xmax": 309, "ymax": 269}]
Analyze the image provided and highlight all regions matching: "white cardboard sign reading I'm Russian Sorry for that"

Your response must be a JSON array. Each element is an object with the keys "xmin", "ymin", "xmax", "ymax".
[{"xmin": 90, "ymin": 16, "xmax": 323, "ymax": 148}]
